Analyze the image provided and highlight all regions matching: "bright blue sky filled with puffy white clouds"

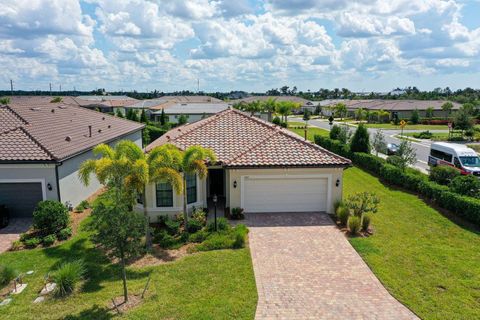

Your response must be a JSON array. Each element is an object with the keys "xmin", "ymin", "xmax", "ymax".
[{"xmin": 0, "ymin": 0, "xmax": 480, "ymax": 91}]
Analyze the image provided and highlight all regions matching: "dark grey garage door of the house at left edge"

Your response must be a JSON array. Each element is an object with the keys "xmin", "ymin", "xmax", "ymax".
[{"xmin": 0, "ymin": 182, "xmax": 43, "ymax": 218}]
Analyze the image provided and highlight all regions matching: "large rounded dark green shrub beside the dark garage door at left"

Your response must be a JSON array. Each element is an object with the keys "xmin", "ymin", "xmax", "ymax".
[{"xmin": 33, "ymin": 200, "xmax": 70, "ymax": 235}]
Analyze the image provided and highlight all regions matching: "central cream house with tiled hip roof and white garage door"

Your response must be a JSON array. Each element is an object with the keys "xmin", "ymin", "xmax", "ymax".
[{"xmin": 141, "ymin": 109, "xmax": 350, "ymax": 218}]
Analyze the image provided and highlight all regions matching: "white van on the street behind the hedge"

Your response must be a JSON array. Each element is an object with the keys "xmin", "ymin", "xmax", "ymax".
[{"xmin": 428, "ymin": 142, "xmax": 480, "ymax": 176}]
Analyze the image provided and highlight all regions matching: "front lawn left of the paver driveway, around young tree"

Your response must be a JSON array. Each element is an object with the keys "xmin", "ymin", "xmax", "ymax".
[{"xmin": 0, "ymin": 220, "xmax": 257, "ymax": 320}]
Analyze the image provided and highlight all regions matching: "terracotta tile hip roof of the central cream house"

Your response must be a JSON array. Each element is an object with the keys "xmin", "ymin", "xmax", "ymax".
[{"xmin": 146, "ymin": 109, "xmax": 350, "ymax": 167}]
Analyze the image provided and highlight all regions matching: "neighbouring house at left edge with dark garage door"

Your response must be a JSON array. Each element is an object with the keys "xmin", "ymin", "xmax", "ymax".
[{"xmin": 0, "ymin": 100, "xmax": 144, "ymax": 217}]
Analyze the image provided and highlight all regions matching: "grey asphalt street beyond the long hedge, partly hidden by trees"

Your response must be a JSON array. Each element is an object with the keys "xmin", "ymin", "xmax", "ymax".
[{"xmin": 291, "ymin": 118, "xmax": 447, "ymax": 172}]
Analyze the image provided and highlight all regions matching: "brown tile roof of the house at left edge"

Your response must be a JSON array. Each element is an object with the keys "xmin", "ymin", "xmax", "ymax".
[{"xmin": 0, "ymin": 99, "xmax": 144, "ymax": 162}]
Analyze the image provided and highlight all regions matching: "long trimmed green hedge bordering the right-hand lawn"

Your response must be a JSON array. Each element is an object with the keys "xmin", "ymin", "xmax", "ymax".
[{"xmin": 315, "ymin": 135, "xmax": 480, "ymax": 226}]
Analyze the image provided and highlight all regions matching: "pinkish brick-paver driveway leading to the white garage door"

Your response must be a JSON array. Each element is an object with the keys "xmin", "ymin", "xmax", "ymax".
[{"xmin": 246, "ymin": 213, "xmax": 418, "ymax": 320}]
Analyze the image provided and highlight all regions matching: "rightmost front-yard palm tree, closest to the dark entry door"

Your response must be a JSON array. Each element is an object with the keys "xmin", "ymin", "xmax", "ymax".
[{"xmin": 179, "ymin": 146, "xmax": 217, "ymax": 227}]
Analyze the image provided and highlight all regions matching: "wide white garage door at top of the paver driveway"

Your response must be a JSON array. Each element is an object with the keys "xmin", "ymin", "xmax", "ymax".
[{"xmin": 243, "ymin": 176, "xmax": 328, "ymax": 212}]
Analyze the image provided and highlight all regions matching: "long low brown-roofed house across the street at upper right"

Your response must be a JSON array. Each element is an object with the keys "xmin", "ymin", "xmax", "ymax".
[{"xmin": 322, "ymin": 99, "xmax": 461, "ymax": 119}]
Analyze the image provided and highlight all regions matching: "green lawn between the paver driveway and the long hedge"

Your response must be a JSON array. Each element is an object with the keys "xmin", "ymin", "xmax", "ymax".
[{"xmin": 344, "ymin": 168, "xmax": 480, "ymax": 319}]
